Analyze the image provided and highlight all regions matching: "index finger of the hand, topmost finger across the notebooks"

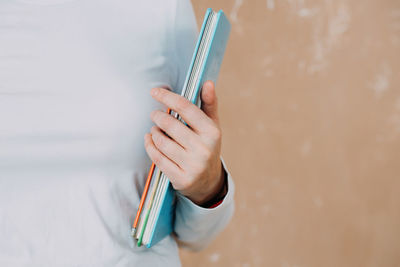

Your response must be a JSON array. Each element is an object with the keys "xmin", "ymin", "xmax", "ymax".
[{"xmin": 151, "ymin": 88, "xmax": 214, "ymax": 133}]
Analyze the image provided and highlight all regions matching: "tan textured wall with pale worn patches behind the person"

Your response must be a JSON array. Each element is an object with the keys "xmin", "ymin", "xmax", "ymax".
[{"xmin": 181, "ymin": 0, "xmax": 400, "ymax": 267}]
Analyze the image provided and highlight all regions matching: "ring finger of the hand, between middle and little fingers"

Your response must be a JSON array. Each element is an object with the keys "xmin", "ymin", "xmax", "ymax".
[{"xmin": 151, "ymin": 126, "xmax": 186, "ymax": 166}]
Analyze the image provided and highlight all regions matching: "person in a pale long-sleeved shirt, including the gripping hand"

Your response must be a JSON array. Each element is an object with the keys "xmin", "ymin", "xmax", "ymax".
[{"xmin": 0, "ymin": 0, "xmax": 234, "ymax": 267}]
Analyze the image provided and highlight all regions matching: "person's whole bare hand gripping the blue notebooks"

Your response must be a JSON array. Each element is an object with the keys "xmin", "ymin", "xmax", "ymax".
[{"xmin": 145, "ymin": 81, "xmax": 225, "ymax": 205}]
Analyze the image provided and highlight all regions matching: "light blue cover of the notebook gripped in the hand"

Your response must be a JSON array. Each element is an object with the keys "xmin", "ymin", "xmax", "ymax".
[{"xmin": 147, "ymin": 8, "xmax": 231, "ymax": 248}]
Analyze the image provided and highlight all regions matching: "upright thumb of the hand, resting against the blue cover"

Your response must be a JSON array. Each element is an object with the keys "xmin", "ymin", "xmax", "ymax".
[{"xmin": 201, "ymin": 80, "xmax": 218, "ymax": 123}]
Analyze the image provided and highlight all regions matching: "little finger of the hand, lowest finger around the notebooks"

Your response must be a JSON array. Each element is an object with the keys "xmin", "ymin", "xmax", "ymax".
[{"xmin": 144, "ymin": 134, "xmax": 183, "ymax": 182}]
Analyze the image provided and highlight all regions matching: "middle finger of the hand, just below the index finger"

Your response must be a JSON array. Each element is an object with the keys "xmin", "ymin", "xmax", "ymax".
[{"xmin": 150, "ymin": 110, "xmax": 197, "ymax": 149}]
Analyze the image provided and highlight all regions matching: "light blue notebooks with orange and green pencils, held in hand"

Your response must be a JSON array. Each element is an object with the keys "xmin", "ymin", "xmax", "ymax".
[{"xmin": 131, "ymin": 8, "xmax": 231, "ymax": 248}]
